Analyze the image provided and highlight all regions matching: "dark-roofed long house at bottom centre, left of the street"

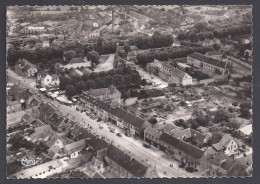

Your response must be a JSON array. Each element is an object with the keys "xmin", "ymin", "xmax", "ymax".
[{"xmin": 105, "ymin": 145, "xmax": 157, "ymax": 178}]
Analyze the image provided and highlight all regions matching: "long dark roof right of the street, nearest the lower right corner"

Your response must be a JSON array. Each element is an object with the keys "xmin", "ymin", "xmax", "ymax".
[{"xmin": 160, "ymin": 133, "xmax": 204, "ymax": 159}]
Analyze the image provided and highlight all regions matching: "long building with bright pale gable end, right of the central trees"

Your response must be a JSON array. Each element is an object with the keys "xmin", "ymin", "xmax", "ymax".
[{"xmin": 146, "ymin": 60, "xmax": 192, "ymax": 86}]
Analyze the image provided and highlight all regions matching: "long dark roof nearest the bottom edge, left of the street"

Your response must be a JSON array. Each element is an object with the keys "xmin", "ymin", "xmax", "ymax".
[{"xmin": 106, "ymin": 145, "xmax": 148, "ymax": 177}]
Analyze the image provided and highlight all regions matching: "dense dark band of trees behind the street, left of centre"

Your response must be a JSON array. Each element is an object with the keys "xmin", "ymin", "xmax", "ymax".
[{"xmin": 59, "ymin": 67, "xmax": 142, "ymax": 98}]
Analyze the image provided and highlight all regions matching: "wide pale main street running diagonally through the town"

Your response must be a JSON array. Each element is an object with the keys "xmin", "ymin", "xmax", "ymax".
[{"xmin": 7, "ymin": 70, "xmax": 198, "ymax": 178}]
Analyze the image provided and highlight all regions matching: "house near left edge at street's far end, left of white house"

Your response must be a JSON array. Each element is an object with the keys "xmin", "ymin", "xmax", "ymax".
[{"xmin": 15, "ymin": 59, "xmax": 38, "ymax": 77}]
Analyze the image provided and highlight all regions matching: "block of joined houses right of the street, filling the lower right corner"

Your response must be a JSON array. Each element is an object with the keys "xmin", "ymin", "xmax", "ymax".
[{"xmin": 144, "ymin": 124, "xmax": 250, "ymax": 176}]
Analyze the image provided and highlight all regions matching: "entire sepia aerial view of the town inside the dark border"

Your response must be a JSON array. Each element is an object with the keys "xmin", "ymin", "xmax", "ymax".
[{"xmin": 6, "ymin": 5, "xmax": 253, "ymax": 179}]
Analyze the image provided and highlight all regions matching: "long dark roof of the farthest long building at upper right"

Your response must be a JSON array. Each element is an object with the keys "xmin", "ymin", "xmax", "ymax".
[{"xmin": 188, "ymin": 52, "xmax": 226, "ymax": 69}]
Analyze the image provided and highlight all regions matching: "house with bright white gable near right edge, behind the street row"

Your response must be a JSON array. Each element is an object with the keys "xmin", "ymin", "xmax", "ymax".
[{"xmin": 212, "ymin": 136, "xmax": 239, "ymax": 156}]
